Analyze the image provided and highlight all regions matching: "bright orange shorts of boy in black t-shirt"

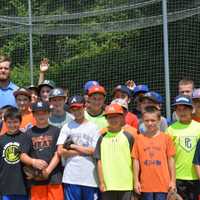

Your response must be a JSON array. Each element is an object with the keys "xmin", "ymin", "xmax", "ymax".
[{"xmin": 31, "ymin": 184, "xmax": 64, "ymax": 200}]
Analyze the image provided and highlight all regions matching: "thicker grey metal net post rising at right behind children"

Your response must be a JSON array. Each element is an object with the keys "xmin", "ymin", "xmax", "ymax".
[{"xmin": 162, "ymin": 0, "xmax": 171, "ymax": 119}]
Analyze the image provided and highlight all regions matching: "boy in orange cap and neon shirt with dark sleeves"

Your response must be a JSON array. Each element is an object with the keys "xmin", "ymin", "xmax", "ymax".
[{"xmin": 94, "ymin": 104, "xmax": 134, "ymax": 200}]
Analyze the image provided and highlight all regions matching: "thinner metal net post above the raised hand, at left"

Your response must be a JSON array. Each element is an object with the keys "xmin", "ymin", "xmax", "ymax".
[{"xmin": 28, "ymin": 0, "xmax": 34, "ymax": 84}]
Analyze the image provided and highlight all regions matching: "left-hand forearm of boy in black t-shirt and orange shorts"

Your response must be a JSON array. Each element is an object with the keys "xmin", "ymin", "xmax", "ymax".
[{"xmin": 20, "ymin": 153, "xmax": 48, "ymax": 170}]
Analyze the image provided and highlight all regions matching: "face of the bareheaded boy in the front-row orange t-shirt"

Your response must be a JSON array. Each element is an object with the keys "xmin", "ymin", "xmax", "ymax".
[{"xmin": 142, "ymin": 113, "xmax": 160, "ymax": 133}]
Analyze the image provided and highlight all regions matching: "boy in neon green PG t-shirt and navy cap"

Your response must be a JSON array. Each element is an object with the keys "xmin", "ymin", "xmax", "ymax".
[{"xmin": 167, "ymin": 95, "xmax": 200, "ymax": 200}]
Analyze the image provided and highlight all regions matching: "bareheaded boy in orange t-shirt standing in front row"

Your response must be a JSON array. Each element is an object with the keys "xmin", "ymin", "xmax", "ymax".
[{"xmin": 132, "ymin": 106, "xmax": 176, "ymax": 200}]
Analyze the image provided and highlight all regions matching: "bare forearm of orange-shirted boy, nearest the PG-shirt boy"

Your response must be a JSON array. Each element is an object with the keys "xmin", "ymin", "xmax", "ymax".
[{"xmin": 168, "ymin": 156, "xmax": 176, "ymax": 191}]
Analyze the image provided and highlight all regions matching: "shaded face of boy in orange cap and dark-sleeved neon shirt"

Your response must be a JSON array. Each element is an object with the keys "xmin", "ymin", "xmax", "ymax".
[{"xmin": 106, "ymin": 114, "xmax": 124, "ymax": 129}]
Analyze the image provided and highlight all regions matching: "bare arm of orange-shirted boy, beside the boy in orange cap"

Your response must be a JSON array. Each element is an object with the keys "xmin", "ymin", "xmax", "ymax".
[{"xmin": 133, "ymin": 159, "xmax": 142, "ymax": 194}]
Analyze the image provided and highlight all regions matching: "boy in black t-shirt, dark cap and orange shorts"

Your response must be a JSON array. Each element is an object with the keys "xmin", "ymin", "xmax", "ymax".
[{"xmin": 21, "ymin": 101, "xmax": 64, "ymax": 200}]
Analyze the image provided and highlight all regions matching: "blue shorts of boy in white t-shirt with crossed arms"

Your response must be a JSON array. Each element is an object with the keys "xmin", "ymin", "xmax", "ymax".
[{"xmin": 64, "ymin": 184, "xmax": 100, "ymax": 200}]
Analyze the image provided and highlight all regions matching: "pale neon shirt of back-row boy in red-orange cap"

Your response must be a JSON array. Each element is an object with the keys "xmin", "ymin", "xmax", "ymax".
[{"xmin": 85, "ymin": 111, "xmax": 108, "ymax": 129}]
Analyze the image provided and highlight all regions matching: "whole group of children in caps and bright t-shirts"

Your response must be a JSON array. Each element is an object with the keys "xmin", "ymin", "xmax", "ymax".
[{"xmin": 0, "ymin": 80, "xmax": 200, "ymax": 200}]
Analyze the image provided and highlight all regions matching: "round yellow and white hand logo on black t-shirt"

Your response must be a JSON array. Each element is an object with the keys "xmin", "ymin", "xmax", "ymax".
[{"xmin": 3, "ymin": 142, "xmax": 20, "ymax": 164}]
